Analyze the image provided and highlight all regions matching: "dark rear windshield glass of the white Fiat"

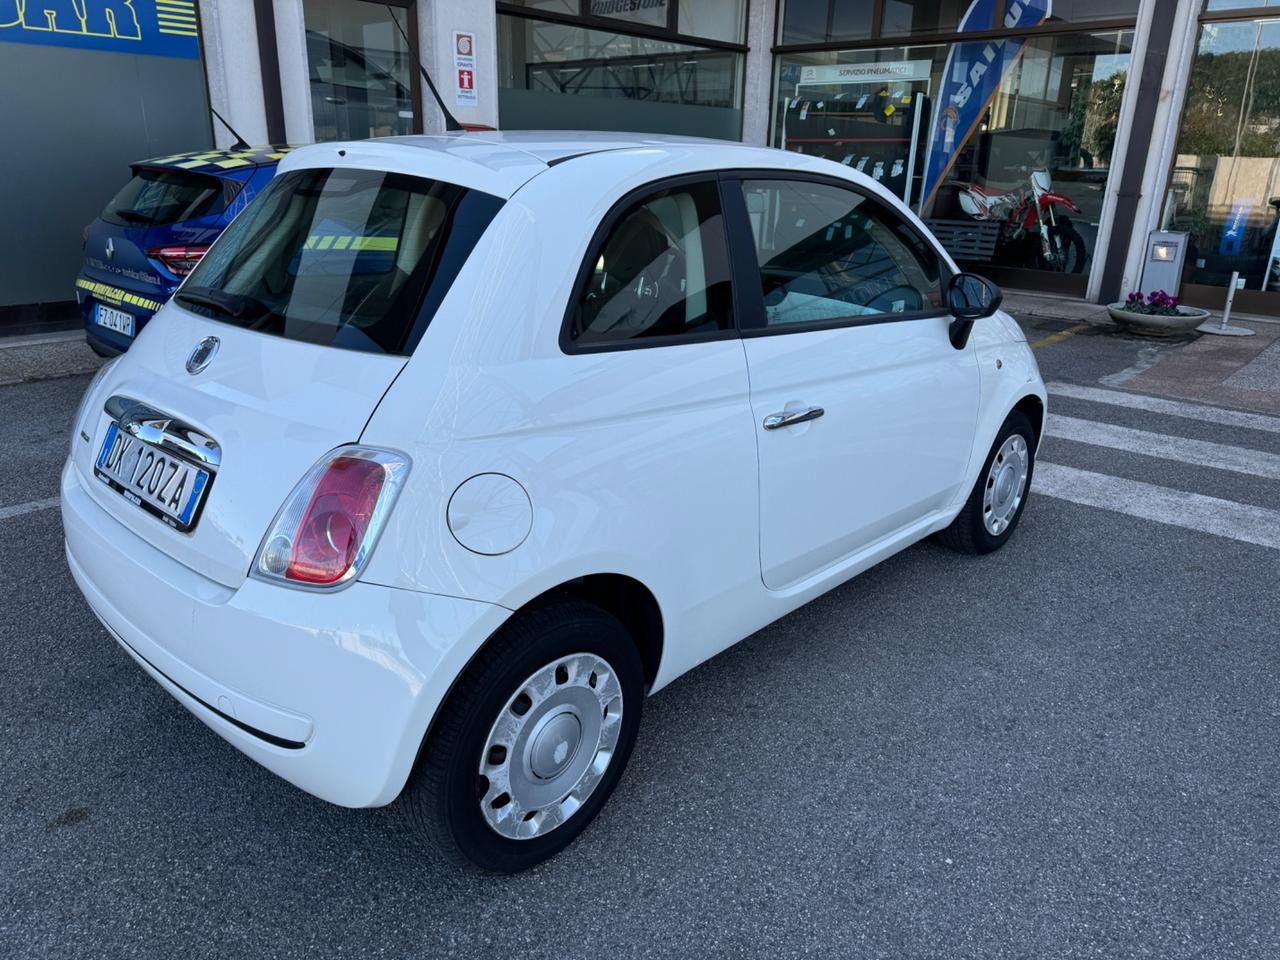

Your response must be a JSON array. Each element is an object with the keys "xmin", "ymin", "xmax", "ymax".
[{"xmin": 177, "ymin": 169, "xmax": 502, "ymax": 355}]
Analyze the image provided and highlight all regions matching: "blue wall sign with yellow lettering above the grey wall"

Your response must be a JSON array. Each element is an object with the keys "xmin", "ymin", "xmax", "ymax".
[{"xmin": 0, "ymin": 0, "xmax": 200, "ymax": 59}]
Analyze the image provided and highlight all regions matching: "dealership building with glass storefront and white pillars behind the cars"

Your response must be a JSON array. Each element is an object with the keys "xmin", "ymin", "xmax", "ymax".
[{"xmin": 0, "ymin": 0, "xmax": 1280, "ymax": 333}]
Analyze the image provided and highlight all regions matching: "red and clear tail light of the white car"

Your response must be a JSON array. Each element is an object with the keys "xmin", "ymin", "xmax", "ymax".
[{"xmin": 252, "ymin": 447, "xmax": 408, "ymax": 589}]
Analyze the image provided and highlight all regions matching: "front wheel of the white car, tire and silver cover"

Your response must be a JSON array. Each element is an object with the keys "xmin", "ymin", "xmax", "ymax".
[{"xmin": 938, "ymin": 410, "xmax": 1036, "ymax": 553}]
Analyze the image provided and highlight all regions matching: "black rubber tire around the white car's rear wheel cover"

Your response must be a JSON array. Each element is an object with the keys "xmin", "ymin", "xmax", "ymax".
[{"xmin": 402, "ymin": 599, "xmax": 644, "ymax": 873}]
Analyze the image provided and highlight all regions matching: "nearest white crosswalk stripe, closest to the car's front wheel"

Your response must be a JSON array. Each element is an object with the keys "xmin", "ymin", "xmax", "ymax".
[{"xmin": 1032, "ymin": 461, "xmax": 1280, "ymax": 550}]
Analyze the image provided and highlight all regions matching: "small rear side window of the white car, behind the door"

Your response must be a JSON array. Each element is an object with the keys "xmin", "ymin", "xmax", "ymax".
[{"xmin": 570, "ymin": 180, "xmax": 733, "ymax": 344}]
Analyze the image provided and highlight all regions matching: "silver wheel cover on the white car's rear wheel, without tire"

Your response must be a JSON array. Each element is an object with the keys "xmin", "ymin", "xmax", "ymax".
[{"xmin": 476, "ymin": 653, "xmax": 622, "ymax": 840}]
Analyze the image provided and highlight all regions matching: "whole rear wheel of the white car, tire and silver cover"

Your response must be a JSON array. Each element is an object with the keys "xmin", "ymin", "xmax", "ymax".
[{"xmin": 404, "ymin": 600, "xmax": 644, "ymax": 873}]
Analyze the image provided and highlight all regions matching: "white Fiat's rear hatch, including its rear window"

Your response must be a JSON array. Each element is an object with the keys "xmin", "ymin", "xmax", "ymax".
[{"xmin": 74, "ymin": 161, "xmax": 500, "ymax": 588}]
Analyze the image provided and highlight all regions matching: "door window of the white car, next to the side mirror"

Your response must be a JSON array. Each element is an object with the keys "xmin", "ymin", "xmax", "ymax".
[{"xmin": 742, "ymin": 179, "xmax": 942, "ymax": 328}]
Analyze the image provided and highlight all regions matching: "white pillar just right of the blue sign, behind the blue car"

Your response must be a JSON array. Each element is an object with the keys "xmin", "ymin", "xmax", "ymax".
[{"xmin": 200, "ymin": 0, "xmax": 268, "ymax": 147}]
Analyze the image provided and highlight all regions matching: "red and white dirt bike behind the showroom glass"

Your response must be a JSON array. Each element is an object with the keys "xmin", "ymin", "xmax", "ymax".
[{"xmin": 957, "ymin": 169, "xmax": 1088, "ymax": 274}]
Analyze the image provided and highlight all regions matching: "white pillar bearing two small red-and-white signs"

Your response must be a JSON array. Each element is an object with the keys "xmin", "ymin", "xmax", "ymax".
[{"xmin": 417, "ymin": 0, "xmax": 498, "ymax": 133}]
